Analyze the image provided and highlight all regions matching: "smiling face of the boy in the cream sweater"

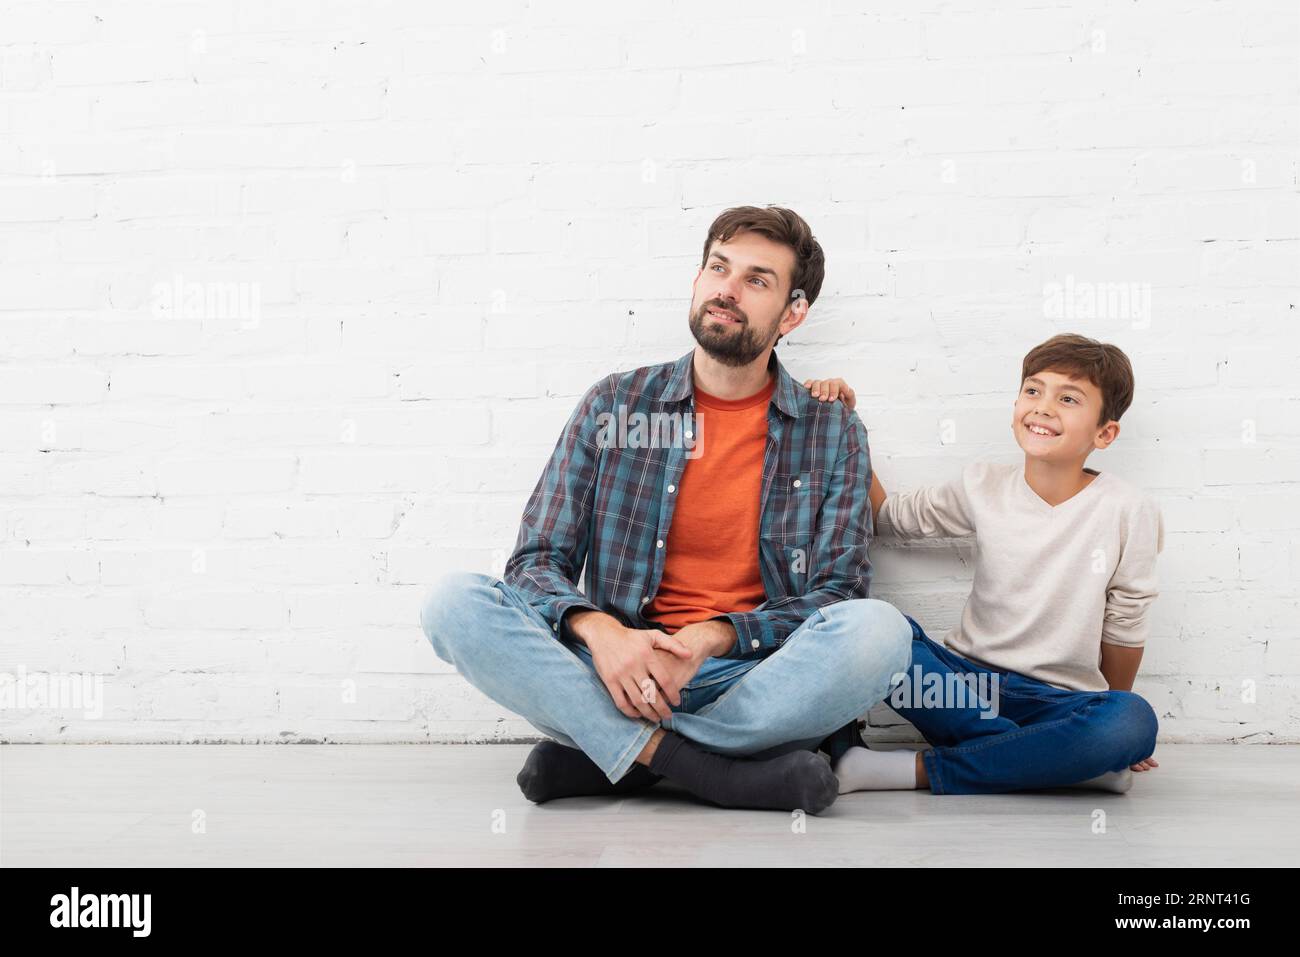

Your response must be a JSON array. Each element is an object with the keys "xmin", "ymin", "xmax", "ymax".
[{"xmin": 1011, "ymin": 369, "xmax": 1119, "ymax": 464}]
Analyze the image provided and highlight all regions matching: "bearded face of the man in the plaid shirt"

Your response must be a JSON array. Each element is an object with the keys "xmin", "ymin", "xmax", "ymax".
[{"xmin": 690, "ymin": 233, "xmax": 806, "ymax": 365}]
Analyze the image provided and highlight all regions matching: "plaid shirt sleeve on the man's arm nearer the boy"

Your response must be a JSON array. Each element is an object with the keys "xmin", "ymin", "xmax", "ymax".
[{"xmin": 719, "ymin": 412, "xmax": 871, "ymax": 658}]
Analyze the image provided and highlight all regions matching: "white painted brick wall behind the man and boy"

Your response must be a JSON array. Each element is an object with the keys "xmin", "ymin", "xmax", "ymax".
[{"xmin": 0, "ymin": 0, "xmax": 1300, "ymax": 741}]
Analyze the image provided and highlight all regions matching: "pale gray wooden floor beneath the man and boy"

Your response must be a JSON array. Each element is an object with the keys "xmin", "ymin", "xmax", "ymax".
[{"xmin": 0, "ymin": 745, "xmax": 1300, "ymax": 867}]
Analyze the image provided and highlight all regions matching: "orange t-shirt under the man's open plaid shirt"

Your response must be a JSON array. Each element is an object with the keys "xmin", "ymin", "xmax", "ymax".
[{"xmin": 642, "ymin": 377, "xmax": 776, "ymax": 632}]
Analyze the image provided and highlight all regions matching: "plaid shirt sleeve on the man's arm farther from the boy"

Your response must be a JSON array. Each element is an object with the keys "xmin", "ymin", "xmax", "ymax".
[{"xmin": 503, "ymin": 377, "xmax": 612, "ymax": 633}]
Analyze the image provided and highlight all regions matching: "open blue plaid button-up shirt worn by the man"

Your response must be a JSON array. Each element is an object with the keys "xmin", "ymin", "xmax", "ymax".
[{"xmin": 504, "ymin": 350, "xmax": 871, "ymax": 658}]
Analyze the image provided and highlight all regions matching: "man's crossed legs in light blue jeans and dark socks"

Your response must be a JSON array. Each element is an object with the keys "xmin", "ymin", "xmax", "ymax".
[{"xmin": 421, "ymin": 572, "xmax": 911, "ymax": 814}]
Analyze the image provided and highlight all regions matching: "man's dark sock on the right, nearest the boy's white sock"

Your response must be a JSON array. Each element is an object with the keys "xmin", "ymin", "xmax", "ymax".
[{"xmin": 650, "ymin": 731, "xmax": 840, "ymax": 814}]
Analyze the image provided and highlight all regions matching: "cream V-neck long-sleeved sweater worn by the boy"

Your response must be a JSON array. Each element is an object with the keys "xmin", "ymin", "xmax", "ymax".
[{"xmin": 876, "ymin": 462, "xmax": 1164, "ymax": 690}]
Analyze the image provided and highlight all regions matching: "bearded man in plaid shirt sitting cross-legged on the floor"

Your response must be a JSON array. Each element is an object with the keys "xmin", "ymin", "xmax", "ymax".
[{"xmin": 421, "ymin": 207, "xmax": 911, "ymax": 814}]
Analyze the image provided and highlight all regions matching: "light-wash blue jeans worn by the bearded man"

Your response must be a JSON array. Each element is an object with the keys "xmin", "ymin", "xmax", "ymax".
[{"xmin": 420, "ymin": 572, "xmax": 911, "ymax": 781}]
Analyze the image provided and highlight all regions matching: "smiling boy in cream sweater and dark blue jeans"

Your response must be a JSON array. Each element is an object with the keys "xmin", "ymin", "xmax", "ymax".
[{"xmin": 805, "ymin": 334, "xmax": 1164, "ymax": 794}]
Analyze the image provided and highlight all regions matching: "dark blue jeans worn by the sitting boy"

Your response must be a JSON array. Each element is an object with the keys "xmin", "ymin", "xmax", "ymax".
[{"xmin": 885, "ymin": 618, "xmax": 1158, "ymax": 794}]
